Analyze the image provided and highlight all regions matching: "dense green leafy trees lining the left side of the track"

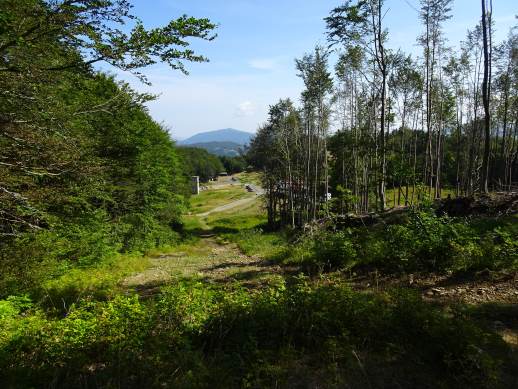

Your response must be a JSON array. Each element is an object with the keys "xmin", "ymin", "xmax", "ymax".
[{"xmin": 0, "ymin": 0, "xmax": 214, "ymax": 295}]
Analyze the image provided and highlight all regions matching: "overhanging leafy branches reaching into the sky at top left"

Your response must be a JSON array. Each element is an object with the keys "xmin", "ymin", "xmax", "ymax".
[{"xmin": 0, "ymin": 0, "xmax": 216, "ymax": 81}]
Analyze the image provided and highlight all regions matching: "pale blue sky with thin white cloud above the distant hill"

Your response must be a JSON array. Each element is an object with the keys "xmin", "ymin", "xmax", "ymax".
[{"xmin": 101, "ymin": 0, "xmax": 518, "ymax": 139}]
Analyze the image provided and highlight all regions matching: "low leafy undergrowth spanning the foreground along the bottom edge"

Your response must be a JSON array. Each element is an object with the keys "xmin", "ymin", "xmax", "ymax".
[{"xmin": 0, "ymin": 278, "xmax": 509, "ymax": 388}]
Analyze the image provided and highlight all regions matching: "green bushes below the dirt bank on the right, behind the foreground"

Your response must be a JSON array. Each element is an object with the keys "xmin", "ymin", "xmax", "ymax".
[{"xmin": 285, "ymin": 209, "xmax": 518, "ymax": 274}]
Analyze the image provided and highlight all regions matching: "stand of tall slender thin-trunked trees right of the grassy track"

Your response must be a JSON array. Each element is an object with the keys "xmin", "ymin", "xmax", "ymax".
[{"xmin": 250, "ymin": 0, "xmax": 518, "ymax": 226}]
